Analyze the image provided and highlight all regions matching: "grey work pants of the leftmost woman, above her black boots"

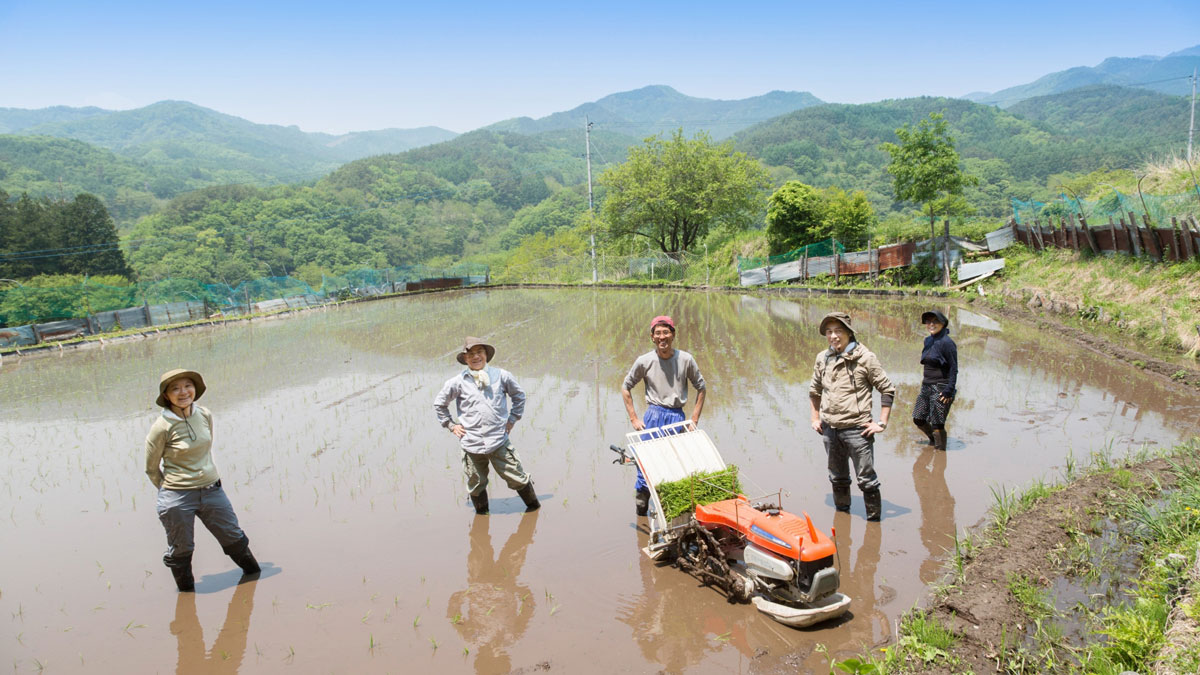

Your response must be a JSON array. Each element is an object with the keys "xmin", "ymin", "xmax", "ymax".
[{"xmin": 156, "ymin": 480, "xmax": 246, "ymax": 558}]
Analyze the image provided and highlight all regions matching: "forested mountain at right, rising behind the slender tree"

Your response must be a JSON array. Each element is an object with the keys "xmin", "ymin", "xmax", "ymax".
[{"xmin": 734, "ymin": 86, "xmax": 1187, "ymax": 216}]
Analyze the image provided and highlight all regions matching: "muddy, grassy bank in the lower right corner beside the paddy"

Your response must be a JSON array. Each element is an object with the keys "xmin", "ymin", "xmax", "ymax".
[{"xmin": 830, "ymin": 440, "xmax": 1200, "ymax": 674}]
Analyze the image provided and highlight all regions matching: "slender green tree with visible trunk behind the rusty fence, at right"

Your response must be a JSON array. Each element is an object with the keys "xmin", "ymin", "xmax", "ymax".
[{"xmin": 881, "ymin": 113, "xmax": 977, "ymax": 285}]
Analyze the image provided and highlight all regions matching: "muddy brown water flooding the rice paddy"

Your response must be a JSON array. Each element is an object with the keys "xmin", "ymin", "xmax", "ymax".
[{"xmin": 0, "ymin": 285, "xmax": 1200, "ymax": 673}]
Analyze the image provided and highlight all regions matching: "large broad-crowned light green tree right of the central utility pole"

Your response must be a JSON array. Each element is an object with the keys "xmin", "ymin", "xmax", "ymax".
[{"xmin": 600, "ymin": 129, "xmax": 768, "ymax": 255}]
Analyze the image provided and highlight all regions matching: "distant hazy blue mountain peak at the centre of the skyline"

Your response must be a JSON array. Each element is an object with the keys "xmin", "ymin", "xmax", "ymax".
[{"xmin": 485, "ymin": 84, "xmax": 823, "ymax": 139}]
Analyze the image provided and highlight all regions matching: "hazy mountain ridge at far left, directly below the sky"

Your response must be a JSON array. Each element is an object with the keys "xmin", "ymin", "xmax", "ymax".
[{"xmin": 0, "ymin": 101, "xmax": 456, "ymax": 214}]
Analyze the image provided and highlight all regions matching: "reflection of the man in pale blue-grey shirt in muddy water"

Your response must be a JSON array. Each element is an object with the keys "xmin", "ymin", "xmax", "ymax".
[{"xmin": 446, "ymin": 510, "xmax": 541, "ymax": 673}]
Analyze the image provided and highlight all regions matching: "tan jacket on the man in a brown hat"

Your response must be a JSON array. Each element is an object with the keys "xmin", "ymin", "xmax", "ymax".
[{"xmin": 809, "ymin": 345, "xmax": 896, "ymax": 429}]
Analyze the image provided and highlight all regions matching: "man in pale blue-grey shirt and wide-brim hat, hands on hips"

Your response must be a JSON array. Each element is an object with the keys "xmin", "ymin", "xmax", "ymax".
[{"xmin": 433, "ymin": 338, "xmax": 541, "ymax": 515}]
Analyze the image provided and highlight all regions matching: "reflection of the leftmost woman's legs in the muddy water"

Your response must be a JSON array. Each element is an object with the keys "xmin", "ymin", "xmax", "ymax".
[{"xmin": 170, "ymin": 579, "xmax": 258, "ymax": 674}]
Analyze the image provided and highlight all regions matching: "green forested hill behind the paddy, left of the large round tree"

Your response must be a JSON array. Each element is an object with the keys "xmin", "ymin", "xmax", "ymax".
[{"xmin": 130, "ymin": 130, "xmax": 634, "ymax": 283}]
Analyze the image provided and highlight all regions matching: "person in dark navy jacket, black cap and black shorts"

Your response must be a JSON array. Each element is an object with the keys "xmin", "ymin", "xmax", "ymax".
[{"xmin": 912, "ymin": 310, "xmax": 959, "ymax": 450}]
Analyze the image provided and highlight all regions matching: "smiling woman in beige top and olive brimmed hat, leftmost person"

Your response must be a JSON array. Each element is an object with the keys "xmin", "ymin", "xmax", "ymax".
[{"xmin": 146, "ymin": 370, "xmax": 260, "ymax": 591}]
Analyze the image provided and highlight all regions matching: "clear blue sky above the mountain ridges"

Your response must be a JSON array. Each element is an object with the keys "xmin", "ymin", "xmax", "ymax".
[{"xmin": 0, "ymin": 0, "xmax": 1200, "ymax": 133}]
